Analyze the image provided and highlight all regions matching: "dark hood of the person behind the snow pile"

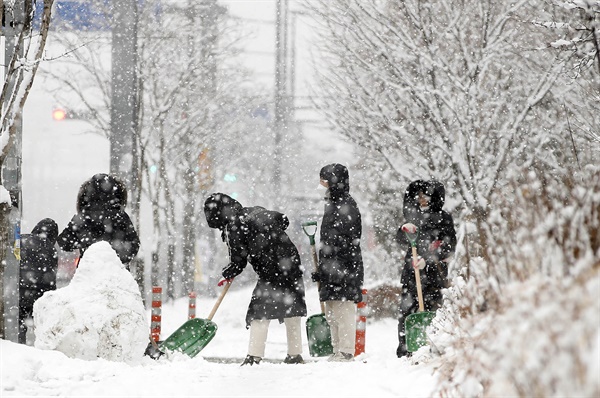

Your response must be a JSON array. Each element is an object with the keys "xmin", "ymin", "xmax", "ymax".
[{"xmin": 77, "ymin": 173, "xmax": 127, "ymax": 212}]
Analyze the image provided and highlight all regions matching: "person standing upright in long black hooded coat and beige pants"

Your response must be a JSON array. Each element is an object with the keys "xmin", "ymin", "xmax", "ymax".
[{"xmin": 312, "ymin": 163, "xmax": 364, "ymax": 361}]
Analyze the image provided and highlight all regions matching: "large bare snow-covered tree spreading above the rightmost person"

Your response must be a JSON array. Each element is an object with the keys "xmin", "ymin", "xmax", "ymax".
[{"xmin": 312, "ymin": 0, "xmax": 562, "ymax": 268}]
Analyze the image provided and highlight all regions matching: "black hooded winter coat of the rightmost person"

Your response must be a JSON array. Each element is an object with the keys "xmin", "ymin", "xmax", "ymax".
[{"xmin": 396, "ymin": 180, "xmax": 456, "ymax": 312}]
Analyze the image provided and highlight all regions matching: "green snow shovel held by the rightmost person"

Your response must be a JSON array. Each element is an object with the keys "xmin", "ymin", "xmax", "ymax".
[{"xmin": 404, "ymin": 227, "xmax": 435, "ymax": 352}]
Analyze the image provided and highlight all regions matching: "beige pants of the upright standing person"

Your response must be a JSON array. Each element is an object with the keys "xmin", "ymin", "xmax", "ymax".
[{"xmin": 325, "ymin": 301, "xmax": 356, "ymax": 355}]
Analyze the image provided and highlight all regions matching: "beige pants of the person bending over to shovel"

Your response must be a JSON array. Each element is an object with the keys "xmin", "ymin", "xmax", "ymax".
[{"xmin": 248, "ymin": 316, "xmax": 302, "ymax": 358}]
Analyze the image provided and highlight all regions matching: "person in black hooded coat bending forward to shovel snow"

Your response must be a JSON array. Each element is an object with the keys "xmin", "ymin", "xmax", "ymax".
[{"xmin": 204, "ymin": 193, "xmax": 306, "ymax": 365}]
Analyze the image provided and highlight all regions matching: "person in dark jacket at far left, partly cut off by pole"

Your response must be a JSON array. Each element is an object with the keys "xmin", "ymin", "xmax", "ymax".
[{"xmin": 19, "ymin": 218, "xmax": 58, "ymax": 344}]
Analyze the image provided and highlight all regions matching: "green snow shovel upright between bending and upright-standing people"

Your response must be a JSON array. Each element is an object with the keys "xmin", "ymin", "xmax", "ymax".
[{"xmin": 302, "ymin": 221, "xmax": 333, "ymax": 357}]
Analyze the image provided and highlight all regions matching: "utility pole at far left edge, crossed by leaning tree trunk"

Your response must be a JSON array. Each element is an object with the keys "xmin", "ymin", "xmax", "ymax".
[{"xmin": 0, "ymin": 0, "xmax": 25, "ymax": 341}]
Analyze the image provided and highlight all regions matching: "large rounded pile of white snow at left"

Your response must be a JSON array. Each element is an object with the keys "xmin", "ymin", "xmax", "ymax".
[{"xmin": 33, "ymin": 242, "xmax": 149, "ymax": 361}]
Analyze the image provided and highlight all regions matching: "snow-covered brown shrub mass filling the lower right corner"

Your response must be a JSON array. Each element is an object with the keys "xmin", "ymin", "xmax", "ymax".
[{"xmin": 428, "ymin": 166, "xmax": 600, "ymax": 396}]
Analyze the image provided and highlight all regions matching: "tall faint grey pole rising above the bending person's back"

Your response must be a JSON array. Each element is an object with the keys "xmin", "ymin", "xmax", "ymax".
[{"xmin": 273, "ymin": 0, "xmax": 289, "ymax": 207}]
